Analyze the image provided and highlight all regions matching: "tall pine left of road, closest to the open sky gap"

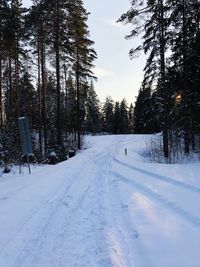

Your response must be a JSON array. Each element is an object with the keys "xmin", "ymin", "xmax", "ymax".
[{"xmin": 68, "ymin": 0, "xmax": 96, "ymax": 149}]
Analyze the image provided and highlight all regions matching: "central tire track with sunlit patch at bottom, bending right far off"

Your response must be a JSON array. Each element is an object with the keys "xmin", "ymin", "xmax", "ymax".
[{"xmin": 90, "ymin": 136, "xmax": 151, "ymax": 267}]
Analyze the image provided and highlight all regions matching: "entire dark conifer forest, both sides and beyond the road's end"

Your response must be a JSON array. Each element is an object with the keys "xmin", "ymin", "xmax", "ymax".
[{"xmin": 0, "ymin": 0, "xmax": 200, "ymax": 164}]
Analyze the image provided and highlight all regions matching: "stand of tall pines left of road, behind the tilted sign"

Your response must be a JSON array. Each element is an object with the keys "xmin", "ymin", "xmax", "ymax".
[{"xmin": 0, "ymin": 0, "xmax": 96, "ymax": 162}]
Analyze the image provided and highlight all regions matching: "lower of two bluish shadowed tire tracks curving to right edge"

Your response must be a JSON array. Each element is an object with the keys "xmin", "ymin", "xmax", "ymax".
[{"xmin": 112, "ymin": 171, "xmax": 200, "ymax": 229}]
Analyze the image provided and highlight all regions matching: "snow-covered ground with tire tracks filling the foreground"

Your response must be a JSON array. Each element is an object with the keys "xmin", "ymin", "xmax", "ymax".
[{"xmin": 0, "ymin": 135, "xmax": 200, "ymax": 267}]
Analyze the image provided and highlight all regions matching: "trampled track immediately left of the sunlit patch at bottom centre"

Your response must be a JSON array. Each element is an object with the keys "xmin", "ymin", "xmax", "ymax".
[{"xmin": 54, "ymin": 157, "xmax": 113, "ymax": 267}]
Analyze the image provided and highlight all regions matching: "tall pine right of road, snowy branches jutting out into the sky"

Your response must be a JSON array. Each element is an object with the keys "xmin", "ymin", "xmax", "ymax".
[{"xmin": 119, "ymin": 0, "xmax": 170, "ymax": 158}]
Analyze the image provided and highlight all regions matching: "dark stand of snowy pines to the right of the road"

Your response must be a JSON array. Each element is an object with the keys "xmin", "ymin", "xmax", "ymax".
[{"xmin": 119, "ymin": 0, "xmax": 200, "ymax": 158}]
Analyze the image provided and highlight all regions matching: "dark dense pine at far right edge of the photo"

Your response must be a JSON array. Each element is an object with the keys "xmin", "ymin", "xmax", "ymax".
[{"xmin": 166, "ymin": 0, "xmax": 200, "ymax": 154}]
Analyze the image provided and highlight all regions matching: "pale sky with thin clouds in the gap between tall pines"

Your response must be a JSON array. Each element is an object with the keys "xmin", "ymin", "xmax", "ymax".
[{"xmin": 22, "ymin": 0, "xmax": 145, "ymax": 103}]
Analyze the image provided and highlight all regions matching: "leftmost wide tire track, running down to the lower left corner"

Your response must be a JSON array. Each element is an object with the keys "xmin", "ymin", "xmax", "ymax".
[{"xmin": 0, "ymin": 164, "xmax": 89, "ymax": 267}]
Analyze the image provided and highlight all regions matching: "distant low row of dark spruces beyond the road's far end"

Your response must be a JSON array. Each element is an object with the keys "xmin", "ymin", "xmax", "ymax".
[{"xmin": 72, "ymin": 94, "xmax": 134, "ymax": 135}]
